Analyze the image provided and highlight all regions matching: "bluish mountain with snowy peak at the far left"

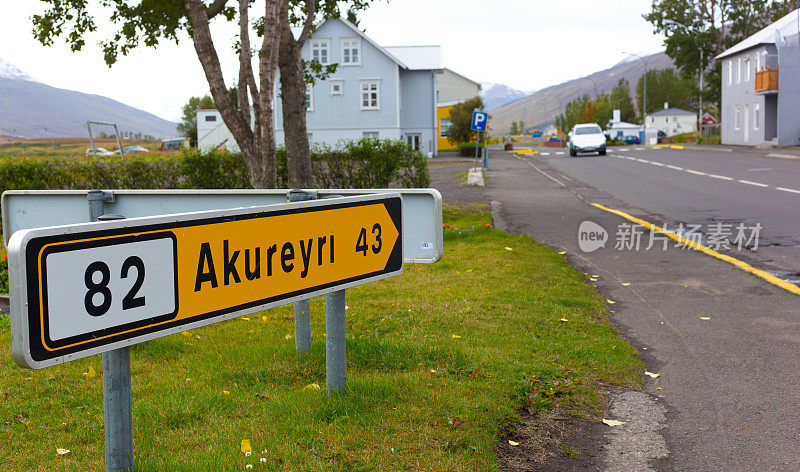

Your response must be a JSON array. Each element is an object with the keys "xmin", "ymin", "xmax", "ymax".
[{"xmin": 0, "ymin": 58, "xmax": 177, "ymax": 138}]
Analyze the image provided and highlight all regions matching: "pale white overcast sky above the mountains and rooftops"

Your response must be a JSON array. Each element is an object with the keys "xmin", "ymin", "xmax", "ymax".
[{"xmin": 0, "ymin": 0, "xmax": 663, "ymax": 121}]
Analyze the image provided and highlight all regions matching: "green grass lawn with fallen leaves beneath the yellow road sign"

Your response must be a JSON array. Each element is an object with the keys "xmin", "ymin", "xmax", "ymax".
[{"xmin": 0, "ymin": 207, "xmax": 642, "ymax": 472}]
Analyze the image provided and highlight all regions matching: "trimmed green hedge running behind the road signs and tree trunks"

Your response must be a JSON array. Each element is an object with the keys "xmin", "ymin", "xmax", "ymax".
[{"xmin": 0, "ymin": 138, "xmax": 430, "ymax": 199}]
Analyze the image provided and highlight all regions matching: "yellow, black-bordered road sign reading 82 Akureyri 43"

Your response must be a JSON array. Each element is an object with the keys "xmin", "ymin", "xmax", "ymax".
[{"xmin": 8, "ymin": 193, "xmax": 403, "ymax": 368}]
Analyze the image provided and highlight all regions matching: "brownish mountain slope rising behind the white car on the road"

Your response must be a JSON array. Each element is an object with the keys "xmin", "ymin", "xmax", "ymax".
[{"xmin": 490, "ymin": 52, "xmax": 674, "ymax": 134}]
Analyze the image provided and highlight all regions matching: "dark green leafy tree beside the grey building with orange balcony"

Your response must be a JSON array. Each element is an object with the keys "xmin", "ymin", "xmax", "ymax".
[{"xmin": 644, "ymin": 0, "xmax": 795, "ymax": 109}]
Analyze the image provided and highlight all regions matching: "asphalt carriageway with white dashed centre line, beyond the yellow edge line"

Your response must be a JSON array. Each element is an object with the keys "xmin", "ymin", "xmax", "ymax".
[{"xmin": 534, "ymin": 146, "xmax": 800, "ymax": 282}]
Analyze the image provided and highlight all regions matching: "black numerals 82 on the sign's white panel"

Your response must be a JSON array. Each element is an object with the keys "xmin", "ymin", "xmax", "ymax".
[{"xmin": 83, "ymin": 256, "xmax": 145, "ymax": 316}]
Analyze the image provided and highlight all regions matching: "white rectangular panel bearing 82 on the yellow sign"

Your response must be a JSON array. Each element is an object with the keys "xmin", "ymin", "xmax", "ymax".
[{"xmin": 42, "ymin": 233, "xmax": 178, "ymax": 343}]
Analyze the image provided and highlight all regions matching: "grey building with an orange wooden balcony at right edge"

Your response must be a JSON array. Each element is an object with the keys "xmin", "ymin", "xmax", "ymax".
[{"xmin": 717, "ymin": 10, "xmax": 800, "ymax": 146}]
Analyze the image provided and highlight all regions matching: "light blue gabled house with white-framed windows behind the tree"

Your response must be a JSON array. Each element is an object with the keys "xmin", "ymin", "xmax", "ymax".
[{"xmin": 275, "ymin": 19, "xmax": 442, "ymax": 156}]
